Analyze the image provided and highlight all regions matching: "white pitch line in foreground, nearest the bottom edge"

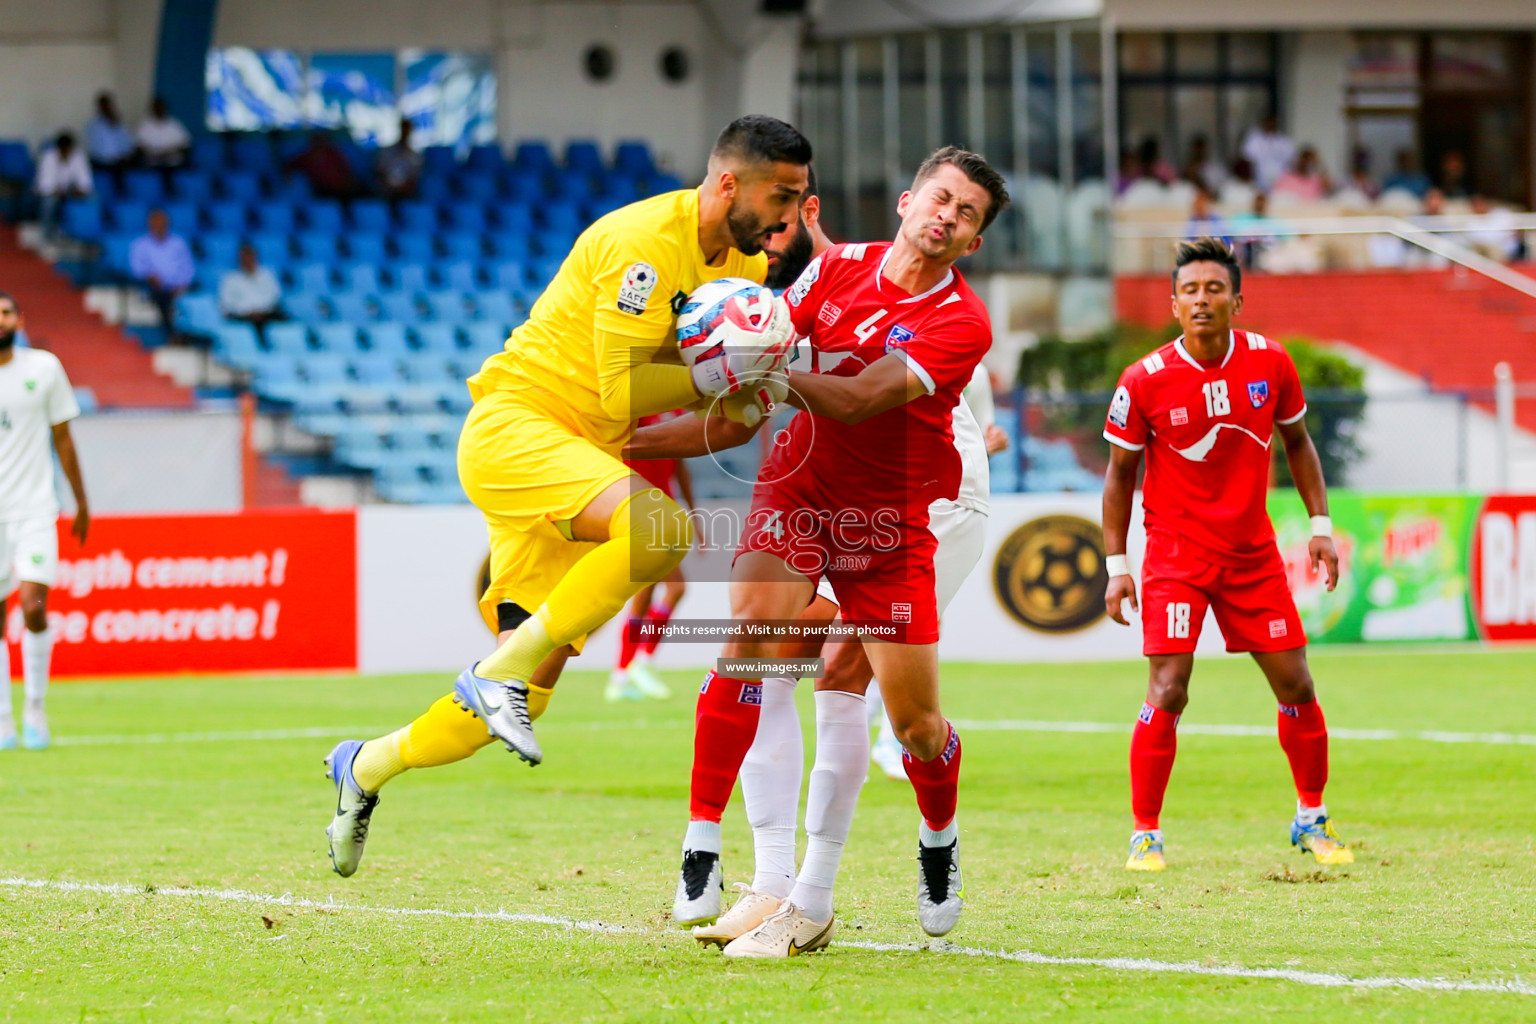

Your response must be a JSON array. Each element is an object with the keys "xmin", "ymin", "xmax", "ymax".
[{"xmin": 0, "ymin": 878, "xmax": 1536, "ymax": 995}]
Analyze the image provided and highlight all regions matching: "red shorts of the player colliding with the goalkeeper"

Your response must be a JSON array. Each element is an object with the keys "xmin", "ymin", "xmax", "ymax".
[{"xmin": 736, "ymin": 481, "xmax": 938, "ymax": 643}]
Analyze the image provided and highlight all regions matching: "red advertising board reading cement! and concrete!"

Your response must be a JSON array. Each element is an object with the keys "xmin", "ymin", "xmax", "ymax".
[{"xmin": 5, "ymin": 510, "xmax": 358, "ymax": 676}]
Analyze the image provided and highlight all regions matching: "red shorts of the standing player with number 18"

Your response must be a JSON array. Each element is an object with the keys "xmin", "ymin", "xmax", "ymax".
[{"xmin": 1141, "ymin": 533, "xmax": 1307, "ymax": 656}]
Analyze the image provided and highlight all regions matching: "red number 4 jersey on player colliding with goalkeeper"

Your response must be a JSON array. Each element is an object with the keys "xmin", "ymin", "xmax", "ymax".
[{"xmin": 774, "ymin": 243, "xmax": 992, "ymax": 513}]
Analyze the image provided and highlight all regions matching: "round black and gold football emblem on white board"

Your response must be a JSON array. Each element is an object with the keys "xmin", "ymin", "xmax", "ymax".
[{"xmin": 992, "ymin": 516, "xmax": 1109, "ymax": 633}]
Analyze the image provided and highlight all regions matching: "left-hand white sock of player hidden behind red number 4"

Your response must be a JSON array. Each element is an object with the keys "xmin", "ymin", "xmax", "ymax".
[{"xmin": 740, "ymin": 679, "xmax": 805, "ymax": 900}]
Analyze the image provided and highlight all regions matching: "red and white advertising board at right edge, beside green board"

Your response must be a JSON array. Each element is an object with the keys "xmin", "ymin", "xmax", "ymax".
[{"xmin": 1467, "ymin": 494, "xmax": 1536, "ymax": 640}]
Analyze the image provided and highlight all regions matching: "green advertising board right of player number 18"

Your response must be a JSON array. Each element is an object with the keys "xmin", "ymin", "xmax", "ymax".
[{"xmin": 1269, "ymin": 490, "xmax": 1482, "ymax": 643}]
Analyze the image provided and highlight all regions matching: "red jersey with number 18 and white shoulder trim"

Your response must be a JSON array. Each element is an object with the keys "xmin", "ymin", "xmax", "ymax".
[{"xmin": 1104, "ymin": 330, "xmax": 1307, "ymax": 565}]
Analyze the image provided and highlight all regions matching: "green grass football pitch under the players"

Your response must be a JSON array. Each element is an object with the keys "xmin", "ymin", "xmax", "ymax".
[{"xmin": 0, "ymin": 649, "xmax": 1536, "ymax": 1022}]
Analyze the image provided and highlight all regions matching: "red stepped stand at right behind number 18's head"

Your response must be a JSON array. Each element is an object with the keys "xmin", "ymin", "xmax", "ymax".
[{"xmin": 1115, "ymin": 267, "xmax": 1536, "ymax": 430}]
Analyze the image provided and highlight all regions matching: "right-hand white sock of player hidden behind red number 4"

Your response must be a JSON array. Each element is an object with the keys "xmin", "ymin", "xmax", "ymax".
[{"xmin": 790, "ymin": 689, "xmax": 869, "ymax": 921}]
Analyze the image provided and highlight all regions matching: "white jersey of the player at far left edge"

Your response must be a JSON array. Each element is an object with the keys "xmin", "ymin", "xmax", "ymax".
[{"xmin": 0, "ymin": 348, "xmax": 80, "ymax": 522}]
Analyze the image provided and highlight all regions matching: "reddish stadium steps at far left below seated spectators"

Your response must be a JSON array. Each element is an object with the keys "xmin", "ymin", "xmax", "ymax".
[{"xmin": 0, "ymin": 226, "xmax": 194, "ymax": 408}]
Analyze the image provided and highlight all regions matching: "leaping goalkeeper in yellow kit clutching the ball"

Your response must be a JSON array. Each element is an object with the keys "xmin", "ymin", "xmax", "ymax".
[{"xmin": 317, "ymin": 115, "xmax": 811, "ymax": 875}]
